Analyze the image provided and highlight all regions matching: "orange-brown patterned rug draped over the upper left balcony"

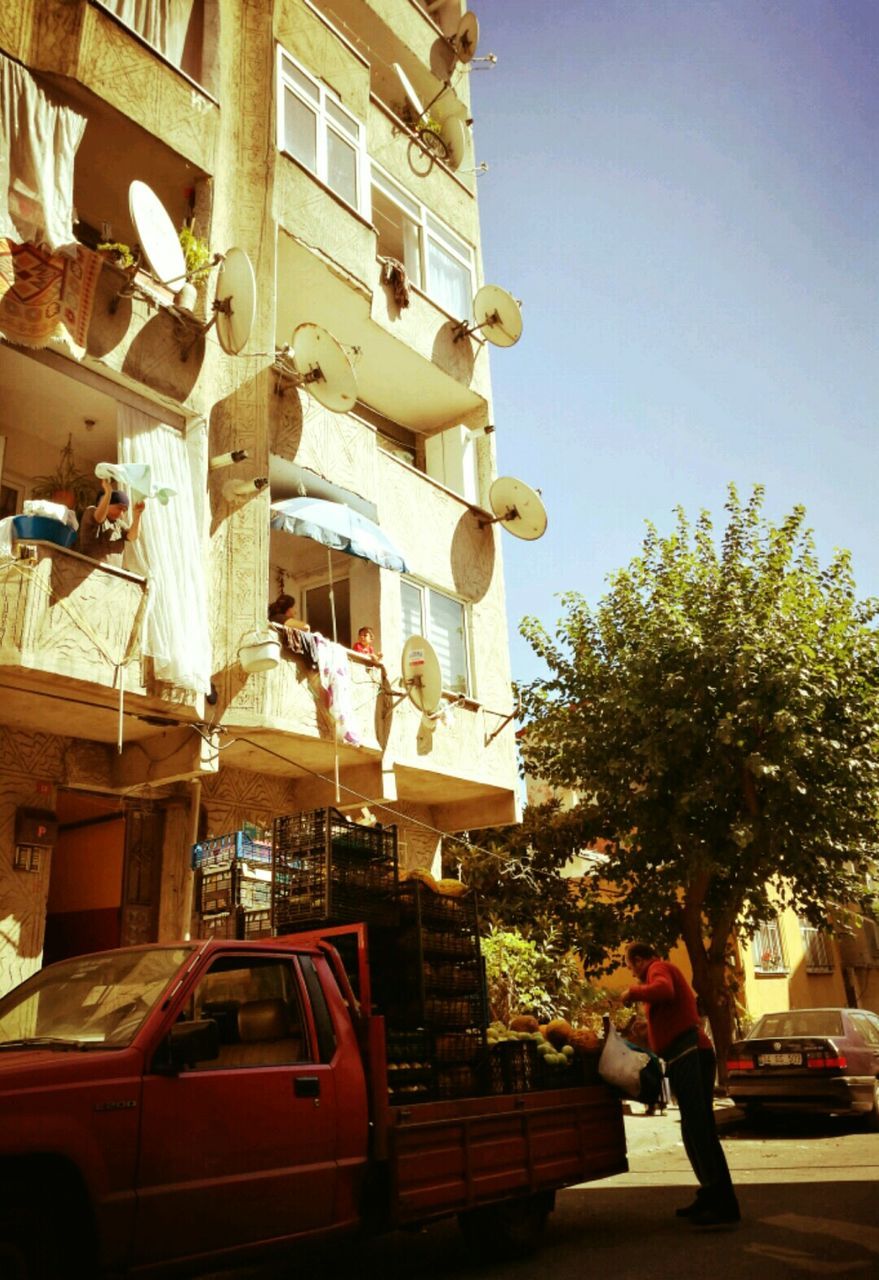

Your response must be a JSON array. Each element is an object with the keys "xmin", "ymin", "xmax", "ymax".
[{"xmin": 0, "ymin": 238, "xmax": 101, "ymax": 349}]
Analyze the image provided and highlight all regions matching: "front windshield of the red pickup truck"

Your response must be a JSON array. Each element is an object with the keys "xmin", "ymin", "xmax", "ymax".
[{"xmin": 0, "ymin": 946, "xmax": 194, "ymax": 1051}]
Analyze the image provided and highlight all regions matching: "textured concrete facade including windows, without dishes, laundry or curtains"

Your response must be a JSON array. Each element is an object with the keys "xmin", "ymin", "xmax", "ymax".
[{"xmin": 0, "ymin": 0, "xmax": 518, "ymax": 991}]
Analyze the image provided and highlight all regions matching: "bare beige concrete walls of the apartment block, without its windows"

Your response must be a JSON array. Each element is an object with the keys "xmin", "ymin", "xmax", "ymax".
[{"xmin": 0, "ymin": 0, "xmax": 518, "ymax": 989}]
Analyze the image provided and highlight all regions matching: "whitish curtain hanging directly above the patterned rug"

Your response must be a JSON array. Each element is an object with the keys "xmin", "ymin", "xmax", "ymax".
[{"xmin": 0, "ymin": 54, "xmax": 86, "ymax": 252}]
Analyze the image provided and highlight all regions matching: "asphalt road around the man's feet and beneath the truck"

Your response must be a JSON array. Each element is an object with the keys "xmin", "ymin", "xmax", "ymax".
[{"xmin": 201, "ymin": 1103, "xmax": 879, "ymax": 1280}]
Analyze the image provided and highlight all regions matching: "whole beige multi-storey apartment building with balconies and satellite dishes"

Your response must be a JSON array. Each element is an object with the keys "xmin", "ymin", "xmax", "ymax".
[{"xmin": 0, "ymin": 0, "xmax": 517, "ymax": 991}]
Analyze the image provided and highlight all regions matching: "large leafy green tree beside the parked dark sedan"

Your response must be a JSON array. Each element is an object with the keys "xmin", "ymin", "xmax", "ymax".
[{"xmin": 522, "ymin": 486, "xmax": 879, "ymax": 1062}]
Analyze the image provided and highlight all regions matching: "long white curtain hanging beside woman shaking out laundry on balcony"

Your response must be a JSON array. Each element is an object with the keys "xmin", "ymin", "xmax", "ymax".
[{"xmin": 118, "ymin": 404, "xmax": 212, "ymax": 694}]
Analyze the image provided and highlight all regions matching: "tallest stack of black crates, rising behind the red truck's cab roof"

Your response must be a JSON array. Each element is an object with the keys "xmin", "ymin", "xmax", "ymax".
[{"xmin": 271, "ymin": 809, "xmax": 398, "ymax": 933}]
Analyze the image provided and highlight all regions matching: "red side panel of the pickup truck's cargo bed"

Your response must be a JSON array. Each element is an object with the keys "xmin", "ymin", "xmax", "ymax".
[{"xmin": 388, "ymin": 1084, "xmax": 628, "ymax": 1226}]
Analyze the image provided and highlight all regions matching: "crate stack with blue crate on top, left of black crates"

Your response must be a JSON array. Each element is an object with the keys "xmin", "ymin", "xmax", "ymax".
[{"xmin": 192, "ymin": 831, "xmax": 271, "ymax": 938}]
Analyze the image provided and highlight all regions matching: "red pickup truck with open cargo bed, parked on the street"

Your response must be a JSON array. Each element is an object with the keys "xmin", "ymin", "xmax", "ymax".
[{"xmin": 0, "ymin": 936, "xmax": 627, "ymax": 1280}]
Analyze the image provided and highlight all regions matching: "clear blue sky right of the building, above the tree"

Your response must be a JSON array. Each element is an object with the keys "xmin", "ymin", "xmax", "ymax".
[{"xmin": 470, "ymin": 0, "xmax": 879, "ymax": 680}]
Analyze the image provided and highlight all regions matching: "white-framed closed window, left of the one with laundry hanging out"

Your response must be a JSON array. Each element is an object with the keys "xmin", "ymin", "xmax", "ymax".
[{"xmin": 275, "ymin": 44, "xmax": 371, "ymax": 219}]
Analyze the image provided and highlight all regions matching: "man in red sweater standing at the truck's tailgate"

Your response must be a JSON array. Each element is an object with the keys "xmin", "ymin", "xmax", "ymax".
[{"xmin": 623, "ymin": 942, "xmax": 741, "ymax": 1226}]
